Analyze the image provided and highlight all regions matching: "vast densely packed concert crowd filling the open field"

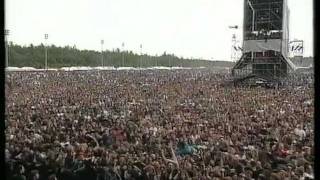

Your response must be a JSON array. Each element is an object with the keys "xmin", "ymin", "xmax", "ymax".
[{"xmin": 5, "ymin": 69, "xmax": 314, "ymax": 180}]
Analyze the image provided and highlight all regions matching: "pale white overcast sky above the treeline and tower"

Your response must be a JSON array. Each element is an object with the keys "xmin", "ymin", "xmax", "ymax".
[{"xmin": 6, "ymin": 0, "xmax": 313, "ymax": 60}]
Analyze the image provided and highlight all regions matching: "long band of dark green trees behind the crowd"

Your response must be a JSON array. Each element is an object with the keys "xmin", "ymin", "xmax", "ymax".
[{"xmin": 9, "ymin": 43, "xmax": 233, "ymax": 68}]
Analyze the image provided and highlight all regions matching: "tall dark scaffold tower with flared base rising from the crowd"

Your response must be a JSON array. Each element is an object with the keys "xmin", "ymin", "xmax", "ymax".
[{"xmin": 232, "ymin": 0, "xmax": 295, "ymax": 81}]
